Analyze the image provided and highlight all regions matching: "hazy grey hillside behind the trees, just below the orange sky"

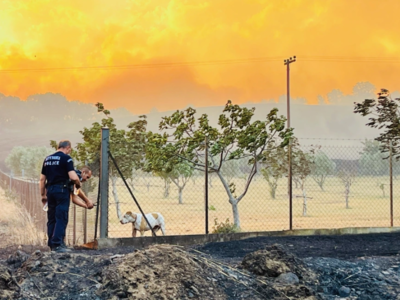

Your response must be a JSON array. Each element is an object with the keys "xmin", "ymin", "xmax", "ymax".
[{"xmin": 0, "ymin": 86, "xmax": 388, "ymax": 168}]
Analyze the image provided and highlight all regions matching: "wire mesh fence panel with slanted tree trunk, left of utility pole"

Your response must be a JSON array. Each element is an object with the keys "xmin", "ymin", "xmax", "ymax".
[{"xmin": 209, "ymin": 160, "xmax": 289, "ymax": 233}]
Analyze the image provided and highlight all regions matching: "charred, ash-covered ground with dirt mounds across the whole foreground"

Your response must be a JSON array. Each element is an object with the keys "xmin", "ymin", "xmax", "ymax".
[{"xmin": 0, "ymin": 233, "xmax": 400, "ymax": 300}]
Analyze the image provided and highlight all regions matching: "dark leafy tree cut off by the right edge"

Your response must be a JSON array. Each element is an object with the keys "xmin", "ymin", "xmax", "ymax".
[{"xmin": 354, "ymin": 89, "xmax": 400, "ymax": 160}]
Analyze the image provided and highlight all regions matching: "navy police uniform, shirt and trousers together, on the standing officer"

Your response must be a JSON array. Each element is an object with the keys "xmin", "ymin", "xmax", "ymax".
[{"xmin": 42, "ymin": 151, "xmax": 74, "ymax": 249}]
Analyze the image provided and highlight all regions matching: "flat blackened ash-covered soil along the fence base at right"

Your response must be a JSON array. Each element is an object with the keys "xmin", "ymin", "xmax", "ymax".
[{"xmin": 194, "ymin": 233, "xmax": 400, "ymax": 300}]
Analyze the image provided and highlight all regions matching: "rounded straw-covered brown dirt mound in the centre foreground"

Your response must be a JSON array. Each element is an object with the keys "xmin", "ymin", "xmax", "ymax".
[{"xmin": 97, "ymin": 245, "xmax": 226, "ymax": 299}]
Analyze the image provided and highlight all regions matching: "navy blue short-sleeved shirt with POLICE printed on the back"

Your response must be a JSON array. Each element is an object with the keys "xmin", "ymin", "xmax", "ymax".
[{"xmin": 42, "ymin": 151, "xmax": 74, "ymax": 186}]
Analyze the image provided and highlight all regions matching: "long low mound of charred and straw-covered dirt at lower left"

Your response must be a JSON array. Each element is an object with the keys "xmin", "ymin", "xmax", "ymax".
[{"xmin": 0, "ymin": 245, "xmax": 227, "ymax": 300}]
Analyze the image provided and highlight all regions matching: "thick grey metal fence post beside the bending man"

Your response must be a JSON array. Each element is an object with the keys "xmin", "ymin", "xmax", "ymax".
[{"xmin": 100, "ymin": 127, "xmax": 110, "ymax": 238}]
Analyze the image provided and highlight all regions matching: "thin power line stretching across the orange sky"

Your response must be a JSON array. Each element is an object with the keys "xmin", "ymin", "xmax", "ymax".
[{"xmin": 0, "ymin": 56, "xmax": 400, "ymax": 74}]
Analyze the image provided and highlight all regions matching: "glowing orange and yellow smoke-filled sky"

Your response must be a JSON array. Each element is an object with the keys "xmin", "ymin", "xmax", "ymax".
[{"xmin": 0, "ymin": 0, "xmax": 400, "ymax": 113}]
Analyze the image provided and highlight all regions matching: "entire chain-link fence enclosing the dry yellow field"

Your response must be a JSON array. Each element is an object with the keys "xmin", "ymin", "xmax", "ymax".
[{"xmin": 0, "ymin": 140, "xmax": 400, "ymax": 244}]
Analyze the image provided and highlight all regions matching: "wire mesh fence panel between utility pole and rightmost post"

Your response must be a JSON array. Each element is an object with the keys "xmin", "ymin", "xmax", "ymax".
[{"xmin": 293, "ymin": 145, "xmax": 390, "ymax": 229}]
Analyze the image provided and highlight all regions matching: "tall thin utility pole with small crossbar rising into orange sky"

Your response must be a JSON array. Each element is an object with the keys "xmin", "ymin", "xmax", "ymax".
[{"xmin": 284, "ymin": 56, "xmax": 296, "ymax": 230}]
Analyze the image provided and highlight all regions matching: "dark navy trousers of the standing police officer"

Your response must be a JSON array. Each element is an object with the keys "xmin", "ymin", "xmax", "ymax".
[{"xmin": 47, "ymin": 185, "xmax": 70, "ymax": 248}]
